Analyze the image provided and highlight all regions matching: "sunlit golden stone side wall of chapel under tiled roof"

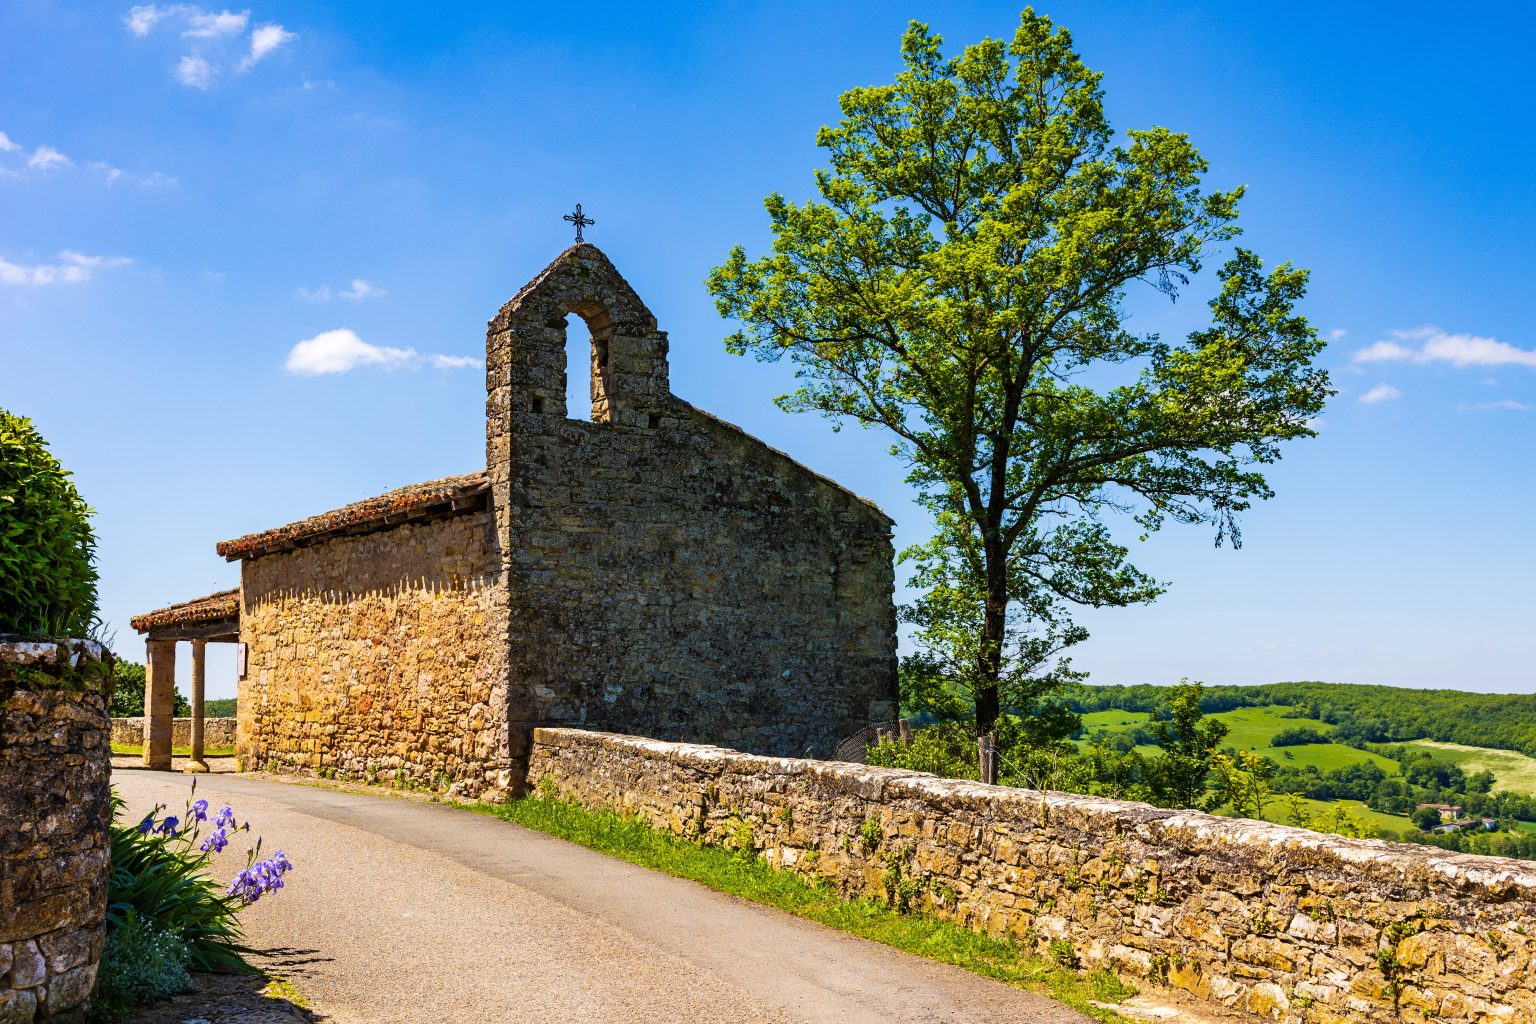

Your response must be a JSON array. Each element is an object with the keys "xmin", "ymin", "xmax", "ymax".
[{"xmin": 237, "ymin": 511, "xmax": 508, "ymax": 795}]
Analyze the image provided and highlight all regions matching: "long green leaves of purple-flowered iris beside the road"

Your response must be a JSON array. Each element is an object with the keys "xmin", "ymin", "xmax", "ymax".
[{"xmin": 108, "ymin": 794, "xmax": 250, "ymax": 972}]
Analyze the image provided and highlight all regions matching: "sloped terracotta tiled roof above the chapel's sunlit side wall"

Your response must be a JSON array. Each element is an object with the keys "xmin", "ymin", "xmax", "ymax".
[{"xmin": 217, "ymin": 470, "xmax": 490, "ymax": 562}]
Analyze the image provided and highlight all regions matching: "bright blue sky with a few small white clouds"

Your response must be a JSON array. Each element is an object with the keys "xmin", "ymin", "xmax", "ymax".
[{"xmin": 0, "ymin": 0, "xmax": 1536, "ymax": 695}]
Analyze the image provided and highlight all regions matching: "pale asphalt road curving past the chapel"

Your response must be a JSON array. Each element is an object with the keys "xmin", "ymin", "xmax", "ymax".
[{"xmin": 112, "ymin": 769, "xmax": 1089, "ymax": 1024}]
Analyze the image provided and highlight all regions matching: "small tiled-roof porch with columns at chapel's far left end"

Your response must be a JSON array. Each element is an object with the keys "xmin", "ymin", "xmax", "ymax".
[{"xmin": 129, "ymin": 590, "xmax": 240, "ymax": 772}]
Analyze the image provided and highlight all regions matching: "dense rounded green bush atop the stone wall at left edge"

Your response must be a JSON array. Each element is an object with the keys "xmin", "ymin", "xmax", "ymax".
[{"xmin": 0, "ymin": 408, "xmax": 97, "ymax": 637}]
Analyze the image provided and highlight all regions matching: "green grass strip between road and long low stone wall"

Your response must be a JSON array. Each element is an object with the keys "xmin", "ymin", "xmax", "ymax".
[{"xmin": 464, "ymin": 797, "xmax": 1137, "ymax": 1021}]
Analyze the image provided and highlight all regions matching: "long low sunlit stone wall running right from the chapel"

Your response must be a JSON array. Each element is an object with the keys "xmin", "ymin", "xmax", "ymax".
[{"xmin": 528, "ymin": 729, "xmax": 1536, "ymax": 1024}]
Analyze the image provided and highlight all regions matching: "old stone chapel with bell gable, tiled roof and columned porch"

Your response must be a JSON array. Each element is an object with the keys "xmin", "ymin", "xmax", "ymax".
[{"xmin": 132, "ymin": 244, "xmax": 895, "ymax": 795}]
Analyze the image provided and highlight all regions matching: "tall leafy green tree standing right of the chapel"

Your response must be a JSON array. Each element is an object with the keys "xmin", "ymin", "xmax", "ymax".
[{"xmin": 708, "ymin": 11, "xmax": 1330, "ymax": 779}]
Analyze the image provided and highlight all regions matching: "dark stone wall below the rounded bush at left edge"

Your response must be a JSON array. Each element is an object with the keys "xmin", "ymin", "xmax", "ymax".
[{"xmin": 0, "ymin": 643, "xmax": 111, "ymax": 1024}]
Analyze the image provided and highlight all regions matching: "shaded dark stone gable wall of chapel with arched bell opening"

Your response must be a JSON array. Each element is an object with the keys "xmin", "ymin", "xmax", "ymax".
[{"xmin": 485, "ymin": 246, "xmax": 895, "ymax": 758}]
